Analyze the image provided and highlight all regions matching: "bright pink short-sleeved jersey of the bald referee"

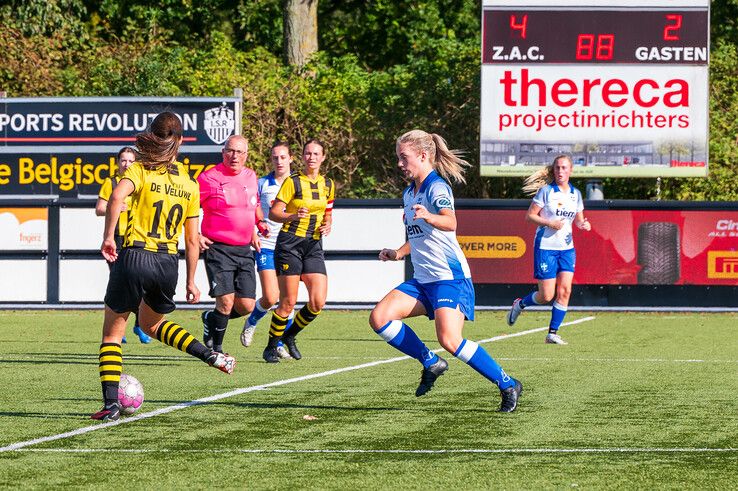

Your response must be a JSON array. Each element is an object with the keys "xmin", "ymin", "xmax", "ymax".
[{"xmin": 197, "ymin": 163, "xmax": 260, "ymax": 245}]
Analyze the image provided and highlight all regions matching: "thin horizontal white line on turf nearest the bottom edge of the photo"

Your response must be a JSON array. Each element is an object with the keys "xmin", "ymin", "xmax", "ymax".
[{"xmin": 11, "ymin": 447, "xmax": 738, "ymax": 454}]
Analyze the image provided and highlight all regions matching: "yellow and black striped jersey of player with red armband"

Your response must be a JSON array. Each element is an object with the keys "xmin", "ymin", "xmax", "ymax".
[{"xmin": 275, "ymin": 172, "xmax": 336, "ymax": 239}]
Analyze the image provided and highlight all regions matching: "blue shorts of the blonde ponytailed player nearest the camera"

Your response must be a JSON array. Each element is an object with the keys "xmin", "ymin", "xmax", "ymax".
[{"xmin": 395, "ymin": 278, "xmax": 474, "ymax": 321}]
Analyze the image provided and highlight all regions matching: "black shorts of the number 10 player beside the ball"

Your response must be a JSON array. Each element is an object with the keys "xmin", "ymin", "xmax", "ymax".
[{"xmin": 105, "ymin": 247, "xmax": 179, "ymax": 314}]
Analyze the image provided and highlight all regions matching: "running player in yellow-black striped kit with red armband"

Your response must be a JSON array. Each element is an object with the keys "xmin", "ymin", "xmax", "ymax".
[{"xmin": 263, "ymin": 139, "xmax": 336, "ymax": 363}]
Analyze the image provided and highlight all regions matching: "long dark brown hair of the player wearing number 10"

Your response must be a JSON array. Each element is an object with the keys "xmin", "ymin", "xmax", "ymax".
[{"xmin": 136, "ymin": 111, "xmax": 182, "ymax": 169}]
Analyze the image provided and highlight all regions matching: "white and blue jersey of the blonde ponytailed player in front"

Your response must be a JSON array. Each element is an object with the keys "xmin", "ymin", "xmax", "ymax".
[{"xmin": 402, "ymin": 171, "xmax": 471, "ymax": 283}]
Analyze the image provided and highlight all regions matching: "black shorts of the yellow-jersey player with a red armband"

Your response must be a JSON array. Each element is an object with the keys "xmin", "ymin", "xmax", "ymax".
[{"xmin": 274, "ymin": 232, "xmax": 326, "ymax": 276}]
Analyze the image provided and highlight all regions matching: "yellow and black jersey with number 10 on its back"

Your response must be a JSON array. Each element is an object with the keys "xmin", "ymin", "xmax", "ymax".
[{"xmin": 123, "ymin": 162, "xmax": 200, "ymax": 254}]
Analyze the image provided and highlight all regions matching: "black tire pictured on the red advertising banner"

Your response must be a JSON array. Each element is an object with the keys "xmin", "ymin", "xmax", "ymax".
[{"xmin": 638, "ymin": 222, "xmax": 681, "ymax": 285}]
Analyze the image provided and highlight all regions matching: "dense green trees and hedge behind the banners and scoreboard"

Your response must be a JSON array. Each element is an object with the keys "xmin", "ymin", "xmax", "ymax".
[{"xmin": 0, "ymin": 0, "xmax": 738, "ymax": 200}]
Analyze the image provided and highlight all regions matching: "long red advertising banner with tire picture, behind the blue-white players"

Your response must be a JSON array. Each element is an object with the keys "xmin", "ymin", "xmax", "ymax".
[{"xmin": 457, "ymin": 210, "xmax": 738, "ymax": 286}]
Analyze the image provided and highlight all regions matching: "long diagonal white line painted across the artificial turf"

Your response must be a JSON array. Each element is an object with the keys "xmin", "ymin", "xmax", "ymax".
[{"xmin": 0, "ymin": 316, "xmax": 595, "ymax": 452}]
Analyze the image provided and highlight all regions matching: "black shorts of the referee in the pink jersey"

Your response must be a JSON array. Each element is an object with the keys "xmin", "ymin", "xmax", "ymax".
[{"xmin": 205, "ymin": 242, "xmax": 256, "ymax": 298}]
